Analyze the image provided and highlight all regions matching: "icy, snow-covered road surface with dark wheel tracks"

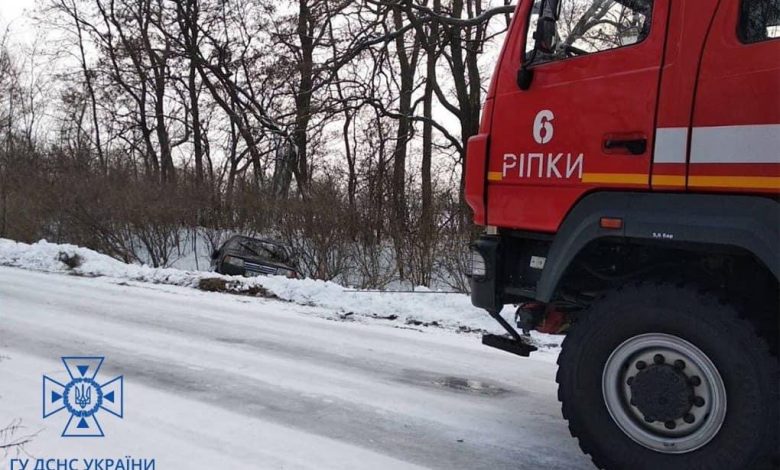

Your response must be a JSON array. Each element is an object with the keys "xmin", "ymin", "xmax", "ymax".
[{"xmin": 0, "ymin": 267, "xmax": 589, "ymax": 470}]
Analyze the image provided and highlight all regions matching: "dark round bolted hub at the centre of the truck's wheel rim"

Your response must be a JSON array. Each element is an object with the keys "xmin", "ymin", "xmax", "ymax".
[{"xmin": 630, "ymin": 364, "xmax": 695, "ymax": 422}]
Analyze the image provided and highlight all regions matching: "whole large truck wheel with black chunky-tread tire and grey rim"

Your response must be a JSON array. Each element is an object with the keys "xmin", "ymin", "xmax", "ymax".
[{"xmin": 557, "ymin": 283, "xmax": 780, "ymax": 470}]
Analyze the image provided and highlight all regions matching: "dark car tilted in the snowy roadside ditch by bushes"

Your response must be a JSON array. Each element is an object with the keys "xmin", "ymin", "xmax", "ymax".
[{"xmin": 211, "ymin": 235, "xmax": 300, "ymax": 278}]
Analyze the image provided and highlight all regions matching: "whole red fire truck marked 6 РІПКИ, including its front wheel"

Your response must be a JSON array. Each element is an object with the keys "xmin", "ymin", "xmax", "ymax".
[{"xmin": 465, "ymin": 0, "xmax": 780, "ymax": 469}]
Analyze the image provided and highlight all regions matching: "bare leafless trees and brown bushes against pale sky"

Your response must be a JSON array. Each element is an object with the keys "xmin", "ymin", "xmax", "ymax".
[{"xmin": 0, "ymin": 0, "xmax": 514, "ymax": 289}]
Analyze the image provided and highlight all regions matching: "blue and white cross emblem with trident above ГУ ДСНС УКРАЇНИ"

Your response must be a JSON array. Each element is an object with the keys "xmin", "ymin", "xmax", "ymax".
[{"xmin": 43, "ymin": 357, "xmax": 124, "ymax": 437}]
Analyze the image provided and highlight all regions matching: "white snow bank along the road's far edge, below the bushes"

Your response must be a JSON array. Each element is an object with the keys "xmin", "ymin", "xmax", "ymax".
[{"xmin": 0, "ymin": 239, "xmax": 561, "ymax": 352}]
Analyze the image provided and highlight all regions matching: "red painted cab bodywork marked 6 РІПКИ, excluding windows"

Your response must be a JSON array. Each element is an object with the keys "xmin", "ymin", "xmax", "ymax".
[{"xmin": 466, "ymin": 0, "xmax": 780, "ymax": 233}]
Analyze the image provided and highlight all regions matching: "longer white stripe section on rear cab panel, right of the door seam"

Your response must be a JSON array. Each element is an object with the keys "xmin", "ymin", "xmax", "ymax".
[{"xmin": 691, "ymin": 124, "xmax": 780, "ymax": 163}]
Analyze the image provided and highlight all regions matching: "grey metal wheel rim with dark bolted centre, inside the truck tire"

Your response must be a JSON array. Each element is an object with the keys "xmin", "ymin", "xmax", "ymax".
[{"xmin": 601, "ymin": 333, "xmax": 726, "ymax": 454}]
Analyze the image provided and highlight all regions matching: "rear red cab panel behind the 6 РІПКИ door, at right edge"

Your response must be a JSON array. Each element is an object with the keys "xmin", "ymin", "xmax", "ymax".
[{"xmin": 687, "ymin": 1, "xmax": 780, "ymax": 194}]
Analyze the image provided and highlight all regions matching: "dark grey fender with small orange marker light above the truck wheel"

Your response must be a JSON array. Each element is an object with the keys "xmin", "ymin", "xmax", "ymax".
[{"xmin": 536, "ymin": 192, "xmax": 780, "ymax": 302}]
